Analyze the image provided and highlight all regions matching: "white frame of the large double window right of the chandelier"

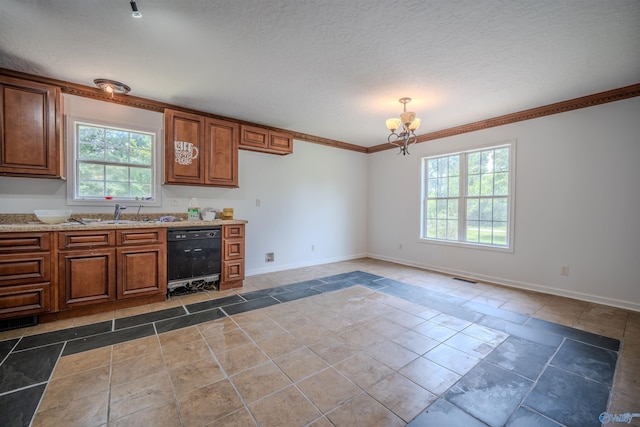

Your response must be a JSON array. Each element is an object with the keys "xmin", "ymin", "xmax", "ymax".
[{"xmin": 419, "ymin": 140, "xmax": 516, "ymax": 253}]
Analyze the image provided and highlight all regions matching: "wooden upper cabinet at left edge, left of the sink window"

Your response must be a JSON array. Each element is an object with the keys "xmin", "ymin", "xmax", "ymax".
[{"xmin": 0, "ymin": 75, "xmax": 64, "ymax": 178}]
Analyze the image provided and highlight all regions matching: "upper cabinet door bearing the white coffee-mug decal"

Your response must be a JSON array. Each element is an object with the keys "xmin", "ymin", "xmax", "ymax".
[{"xmin": 164, "ymin": 109, "xmax": 205, "ymax": 184}]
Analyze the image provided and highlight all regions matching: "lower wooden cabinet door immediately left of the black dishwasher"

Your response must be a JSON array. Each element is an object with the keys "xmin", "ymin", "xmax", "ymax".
[{"xmin": 116, "ymin": 245, "xmax": 167, "ymax": 299}]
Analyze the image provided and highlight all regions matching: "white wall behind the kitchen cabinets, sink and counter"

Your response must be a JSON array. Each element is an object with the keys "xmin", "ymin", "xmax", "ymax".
[{"xmin": 0, "ymin": 95, "xmax": 367, "ymax": 275}]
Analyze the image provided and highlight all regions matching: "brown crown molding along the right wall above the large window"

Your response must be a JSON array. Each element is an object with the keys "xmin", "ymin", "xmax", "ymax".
[{"xmin": 367, "ymin": 83, "xmax": 640, "ymax": 154}]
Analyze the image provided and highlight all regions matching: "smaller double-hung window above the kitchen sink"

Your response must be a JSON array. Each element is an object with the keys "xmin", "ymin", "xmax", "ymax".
[{"xmin": 68, "ymin": 119, "xmax": 159, "ymax": 205}]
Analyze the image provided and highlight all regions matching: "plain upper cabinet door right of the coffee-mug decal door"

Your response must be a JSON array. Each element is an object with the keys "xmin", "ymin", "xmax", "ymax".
[{"xmin": 205, "ymin": 119, "xmax": 240, "ymax": 187}]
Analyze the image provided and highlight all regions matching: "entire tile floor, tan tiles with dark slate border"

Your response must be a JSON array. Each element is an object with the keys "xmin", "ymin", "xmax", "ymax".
[{"xmin": 0, "ymin": 259, "xmax": 640, "ymax": 426}]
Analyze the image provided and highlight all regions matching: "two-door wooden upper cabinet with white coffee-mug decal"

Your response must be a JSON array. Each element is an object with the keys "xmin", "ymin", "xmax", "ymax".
[{"xmin": 164, "ymin": 109, "xmax": 239, "ymax": 187}]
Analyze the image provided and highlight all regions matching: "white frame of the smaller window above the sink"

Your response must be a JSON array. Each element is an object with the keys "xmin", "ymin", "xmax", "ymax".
[{"xmin": 65, "ymin": 116, "xmax": 162, "ymax": 207}]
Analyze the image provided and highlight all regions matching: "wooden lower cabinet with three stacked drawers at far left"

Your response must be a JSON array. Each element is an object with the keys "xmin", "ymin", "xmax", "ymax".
[{"xmin": 0, "ymin": 232, "xmax": 51, "ymax": 319}]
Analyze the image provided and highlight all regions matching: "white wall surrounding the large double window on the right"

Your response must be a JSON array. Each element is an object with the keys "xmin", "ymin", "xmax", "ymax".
[{"xmin": 368, "ymin": 98, "xmax": 640, "ymax": 311}]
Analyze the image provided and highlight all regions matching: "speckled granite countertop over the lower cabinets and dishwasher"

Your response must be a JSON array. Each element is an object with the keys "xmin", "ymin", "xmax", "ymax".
[{"xmin": 0, "ymin": 214, "xmax": 248, "ymax": 233}]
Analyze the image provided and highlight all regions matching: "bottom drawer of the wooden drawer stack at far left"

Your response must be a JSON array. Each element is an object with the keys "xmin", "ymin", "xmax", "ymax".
[{"xmin": 0, "ymin": 283, "xmax": 51, "ymax": 319}]
